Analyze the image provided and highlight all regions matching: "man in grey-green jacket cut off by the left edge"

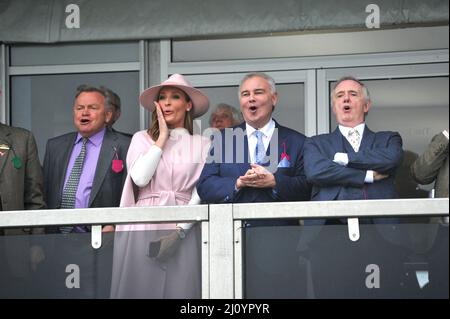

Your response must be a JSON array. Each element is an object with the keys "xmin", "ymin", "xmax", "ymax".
[{"xmin": 0, "ymin": 123, "xmax": 45, "ymax": 298}]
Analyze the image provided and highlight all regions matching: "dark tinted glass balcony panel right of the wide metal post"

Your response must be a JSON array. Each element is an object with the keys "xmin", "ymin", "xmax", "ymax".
[{"xmin": 244, "ymin": 218, "xmax": 449, "ymax": 299}]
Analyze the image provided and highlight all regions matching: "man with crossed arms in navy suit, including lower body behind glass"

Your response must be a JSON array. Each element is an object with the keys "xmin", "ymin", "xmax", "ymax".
[{"xmin": 305, "ymin": 77, "xmax": 405, "ymax": 298}]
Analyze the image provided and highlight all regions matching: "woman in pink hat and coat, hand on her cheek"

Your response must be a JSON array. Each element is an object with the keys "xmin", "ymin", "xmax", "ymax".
[{"xmin": 111, "ymin": 74, "xmax": 210, "ymax": 298}]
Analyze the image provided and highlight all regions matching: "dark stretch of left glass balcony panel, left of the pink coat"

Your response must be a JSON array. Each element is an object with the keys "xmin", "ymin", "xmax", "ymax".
[{"xmin": 0, "ymin": 233, "xmax": 113, "ymax": 299}]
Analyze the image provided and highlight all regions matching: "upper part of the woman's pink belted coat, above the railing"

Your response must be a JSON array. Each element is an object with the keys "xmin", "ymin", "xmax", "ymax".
[{"xmin": 116, "ymin": 129, "xmax": 210, "ymax": 231}]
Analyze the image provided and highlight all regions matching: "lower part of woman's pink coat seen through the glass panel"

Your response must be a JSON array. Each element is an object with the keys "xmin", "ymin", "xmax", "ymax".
[{"xmin": 110, "ymin": 226, "xmax": 201, "ymax": 299}]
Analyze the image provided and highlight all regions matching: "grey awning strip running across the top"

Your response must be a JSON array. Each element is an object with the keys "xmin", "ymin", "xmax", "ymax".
[{"xmin": 0, "ymin": 0, "xmax": 448, "ymax": 43}]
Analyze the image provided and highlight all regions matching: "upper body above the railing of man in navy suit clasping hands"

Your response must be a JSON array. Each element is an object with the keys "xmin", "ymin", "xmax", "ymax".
[{"xmin": 197, "ymin": 73, "xmax": 310, "ymax": 203}]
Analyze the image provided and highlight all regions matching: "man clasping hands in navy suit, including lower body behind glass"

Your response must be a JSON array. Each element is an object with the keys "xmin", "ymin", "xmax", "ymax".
[{"xmin": 197, "ymin": 73, "xmax": 310, "ymax": 298}]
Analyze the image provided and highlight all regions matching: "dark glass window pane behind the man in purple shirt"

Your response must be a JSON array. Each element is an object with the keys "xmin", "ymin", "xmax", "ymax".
[{"xmin": 11, "ymin": 72, "xmax": 140, "ymax": 162}]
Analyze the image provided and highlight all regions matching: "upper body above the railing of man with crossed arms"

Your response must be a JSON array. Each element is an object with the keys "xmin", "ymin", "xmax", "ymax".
[{"xmin": 305, "ymin": 77, "xmax": 403, "ymax": 200}]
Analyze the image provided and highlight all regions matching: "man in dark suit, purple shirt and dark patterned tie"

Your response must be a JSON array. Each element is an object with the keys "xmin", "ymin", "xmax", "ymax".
[{"xmin": 44, "ymin": 85, "xmax": 131, "ymax": 298}]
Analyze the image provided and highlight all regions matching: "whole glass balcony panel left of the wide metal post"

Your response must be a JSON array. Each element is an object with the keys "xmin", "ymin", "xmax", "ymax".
[{"xmin": 0, "ymin": 227, "xmax": 202, "ymax": 299}]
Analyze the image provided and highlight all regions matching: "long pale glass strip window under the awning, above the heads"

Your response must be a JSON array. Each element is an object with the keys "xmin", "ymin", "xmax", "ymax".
[{"xmin": 172, "ymin": 25, "xmax": 449, "ymax": 62}]
